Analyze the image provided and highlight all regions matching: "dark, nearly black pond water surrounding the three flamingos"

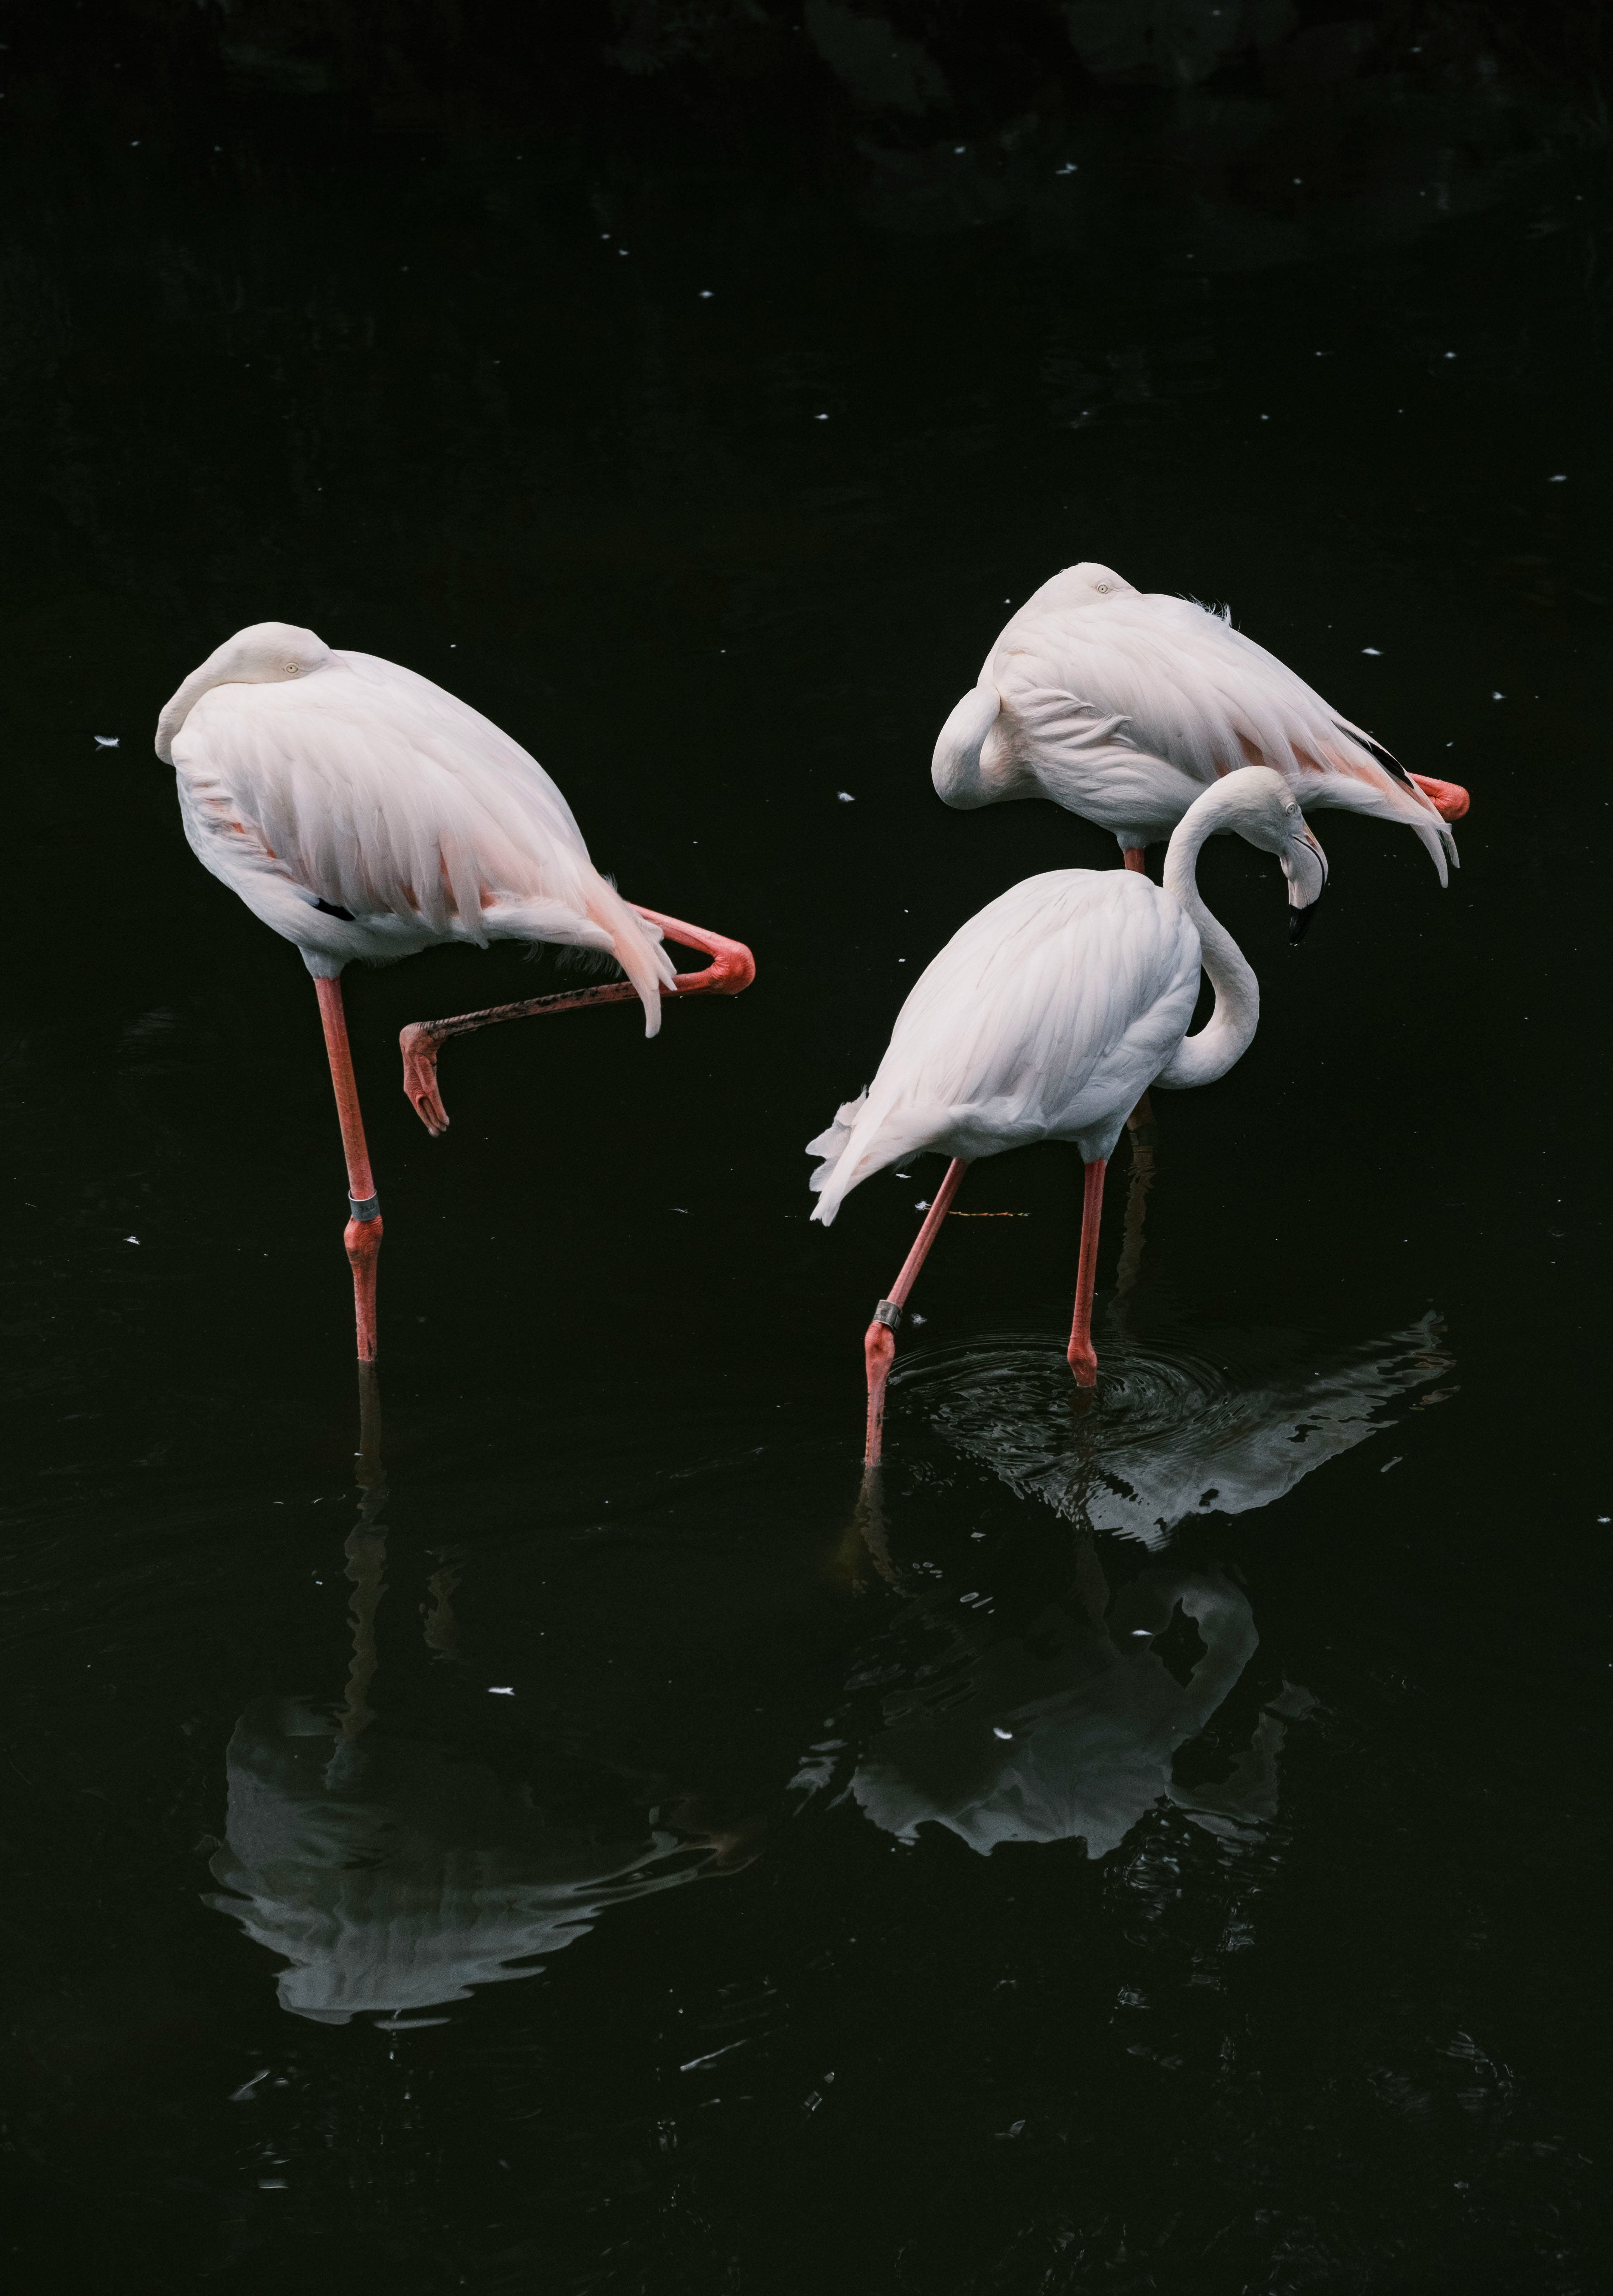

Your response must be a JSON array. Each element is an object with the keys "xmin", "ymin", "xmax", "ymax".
[{"xmin": 2, "ymin": 9, "xmax": 1613, "ymax": 2296}]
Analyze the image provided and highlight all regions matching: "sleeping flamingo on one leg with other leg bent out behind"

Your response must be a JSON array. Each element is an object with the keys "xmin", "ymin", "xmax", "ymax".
[{"xmin": 156, "ymin": 622, "xmax": 754, "ymax": 1364}]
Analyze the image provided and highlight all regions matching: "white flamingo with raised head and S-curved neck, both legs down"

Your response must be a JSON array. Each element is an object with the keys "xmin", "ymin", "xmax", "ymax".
[{"xmin": 806, "ymin": 765, "xmax": 1328, "ymax": 1467}]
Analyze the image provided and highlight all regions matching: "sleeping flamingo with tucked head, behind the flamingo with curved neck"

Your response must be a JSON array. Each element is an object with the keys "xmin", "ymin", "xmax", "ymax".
[{"xmin": 931, "ymin": 565, "xmax": 1468, "ymax": 918}]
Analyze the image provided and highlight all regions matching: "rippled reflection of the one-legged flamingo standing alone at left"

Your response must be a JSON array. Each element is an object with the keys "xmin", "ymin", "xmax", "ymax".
[{"xmin": 207, "ymin": 1366, "xmax": 758, "ymax": 2025}]
